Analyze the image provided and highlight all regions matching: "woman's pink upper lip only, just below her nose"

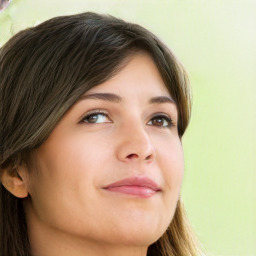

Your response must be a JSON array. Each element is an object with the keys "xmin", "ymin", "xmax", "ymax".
[{"xmin": 104, "ymin": 176, "xmax": 161, "ymax": 191}]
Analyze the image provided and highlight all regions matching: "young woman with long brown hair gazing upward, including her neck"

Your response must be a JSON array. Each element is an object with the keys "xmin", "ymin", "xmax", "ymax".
[{"xmin": 0, "ymin": 13, "xmax": 201, "ymax": 256}]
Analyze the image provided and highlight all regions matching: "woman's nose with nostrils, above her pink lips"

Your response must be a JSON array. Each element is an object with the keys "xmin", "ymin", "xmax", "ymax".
[{"xmin": 117, "ymin": 125, "xmax": 156, "ymax": 162}]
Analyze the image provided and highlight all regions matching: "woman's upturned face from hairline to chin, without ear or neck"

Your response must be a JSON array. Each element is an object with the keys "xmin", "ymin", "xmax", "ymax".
[{"xmin": 25, "ymin": 53, "xmax": 183, "ymax": 250}]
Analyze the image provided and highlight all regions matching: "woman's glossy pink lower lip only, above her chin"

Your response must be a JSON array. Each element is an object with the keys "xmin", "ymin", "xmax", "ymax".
[{"xmin": 106, "ymin": 186, "xmax": 157, "ymax": 198}]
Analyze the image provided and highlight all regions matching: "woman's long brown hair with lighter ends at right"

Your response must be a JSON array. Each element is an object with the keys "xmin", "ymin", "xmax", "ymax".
[{"xmin": 0, "ymin": 12, "xmax": 200, "ymax": 256}]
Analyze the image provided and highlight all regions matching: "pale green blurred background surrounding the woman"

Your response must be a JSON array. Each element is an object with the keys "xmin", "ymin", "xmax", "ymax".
[{"xmin": 0, "ymin": 0, "xmax": 256, "ymax": 256}]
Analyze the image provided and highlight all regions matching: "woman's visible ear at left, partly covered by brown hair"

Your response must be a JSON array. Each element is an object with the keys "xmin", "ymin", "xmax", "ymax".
[{"xmin": 0, "ymin": 166, "xmax": 28, "ymax": 198}]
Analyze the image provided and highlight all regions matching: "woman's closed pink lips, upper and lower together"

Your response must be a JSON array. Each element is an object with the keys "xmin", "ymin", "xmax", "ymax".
[{"xmin": 104, "ymin": 176, "xmax": 161, "ymax": 198}]
